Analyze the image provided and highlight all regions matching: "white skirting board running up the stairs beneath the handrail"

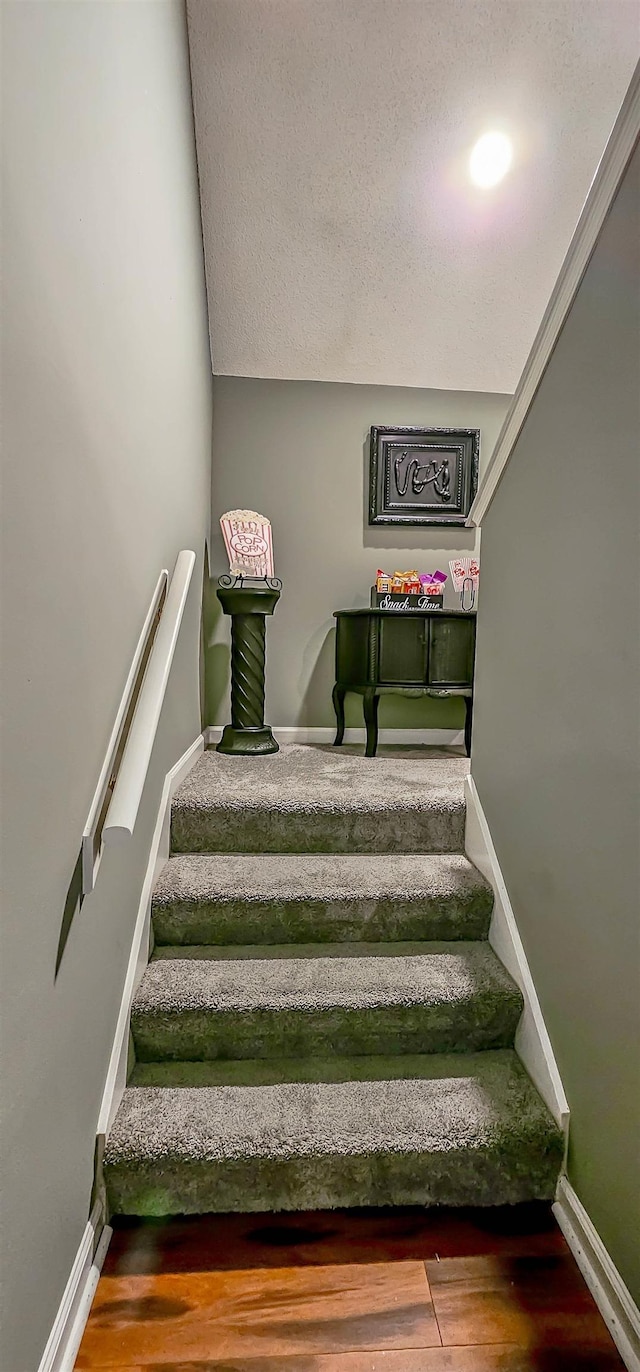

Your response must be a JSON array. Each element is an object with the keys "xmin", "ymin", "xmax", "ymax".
[{"xmin": 96, "ymin": 734, "xmax": 205, "ymax": 1146}]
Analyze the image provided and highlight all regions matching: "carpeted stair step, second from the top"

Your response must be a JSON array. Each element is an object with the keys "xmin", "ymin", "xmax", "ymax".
[{"xmin": 152, "ymin": 853, "xmax": 493, "ymax": 945}]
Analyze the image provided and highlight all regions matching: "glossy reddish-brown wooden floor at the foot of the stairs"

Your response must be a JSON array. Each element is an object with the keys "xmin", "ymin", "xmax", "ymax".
[{"xmin": 76, "ymin": 1206, "xmax": 624, "ymax": 1372}]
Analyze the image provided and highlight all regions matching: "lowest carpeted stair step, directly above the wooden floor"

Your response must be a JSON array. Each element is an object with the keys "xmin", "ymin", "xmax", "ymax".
[{"xmin": 104, "ymin": 1050, "xmax": 563, "ymax": 1216}]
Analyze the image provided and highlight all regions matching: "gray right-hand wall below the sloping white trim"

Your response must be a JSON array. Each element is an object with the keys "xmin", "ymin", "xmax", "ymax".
[{"xmin": 472, "ymin": 154, "xmax": 640, "ymax": 1299}]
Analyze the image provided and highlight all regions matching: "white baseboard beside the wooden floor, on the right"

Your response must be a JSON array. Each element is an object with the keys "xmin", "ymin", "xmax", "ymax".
[{"xmin": 553, "ymin": 1176, "xmax": 640, "ymax": 1372}]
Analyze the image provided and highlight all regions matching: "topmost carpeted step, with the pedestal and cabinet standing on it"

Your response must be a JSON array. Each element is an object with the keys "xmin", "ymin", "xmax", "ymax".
[{"xmin": 172, "ymin": 744, "xmax": 468, "ymax": 853}]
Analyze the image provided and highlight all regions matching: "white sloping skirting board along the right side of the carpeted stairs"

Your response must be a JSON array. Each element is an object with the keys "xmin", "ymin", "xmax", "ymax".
[{"xmin": 464, "ymin": 777, "xmax": 569, "ymax": 1139}]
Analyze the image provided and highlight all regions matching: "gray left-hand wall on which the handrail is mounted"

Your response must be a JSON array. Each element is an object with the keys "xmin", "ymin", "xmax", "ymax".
[{"xmin": 0, "ymin": 0, "xmax": 212, "ymax": 1372}]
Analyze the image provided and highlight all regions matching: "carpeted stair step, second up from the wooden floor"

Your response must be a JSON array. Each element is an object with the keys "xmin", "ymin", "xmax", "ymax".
[{"xmin": 132, "ymin": 943, "xmax": 522, "ymax": 1062}]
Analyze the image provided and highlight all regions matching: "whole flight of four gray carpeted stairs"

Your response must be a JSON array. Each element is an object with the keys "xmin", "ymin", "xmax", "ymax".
[{"xmin": 104, "ymin": 746, "xmax": 563, "ymax": 1216}]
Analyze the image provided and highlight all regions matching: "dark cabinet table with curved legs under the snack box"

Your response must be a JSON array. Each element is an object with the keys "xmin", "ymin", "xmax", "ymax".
[{"xmin": 334, "ymin": 609, "xmax": 475, "ymax": 757}]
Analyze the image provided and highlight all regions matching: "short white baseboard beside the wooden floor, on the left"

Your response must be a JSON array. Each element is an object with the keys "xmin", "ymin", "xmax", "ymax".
[{"xmin": 38, "ymin": 1201, "xmax": 113, "ymax": 1372}]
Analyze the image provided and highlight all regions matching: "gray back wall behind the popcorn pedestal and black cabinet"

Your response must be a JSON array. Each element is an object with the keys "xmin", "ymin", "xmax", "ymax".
[{"xmin": 207, "ymin": 376, "xmax": 508, "ymax": 729}]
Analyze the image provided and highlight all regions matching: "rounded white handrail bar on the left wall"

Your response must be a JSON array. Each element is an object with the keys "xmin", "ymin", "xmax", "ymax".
[{"xmin": 103, "ymin": 549, "xmax": 195, "ymax": 845}]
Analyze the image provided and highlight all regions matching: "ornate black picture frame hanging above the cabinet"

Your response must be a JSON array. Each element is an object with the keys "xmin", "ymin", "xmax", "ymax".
[{"xmin": 369, "ymin": 425, "xmax": 479, "ymax": 525}]
